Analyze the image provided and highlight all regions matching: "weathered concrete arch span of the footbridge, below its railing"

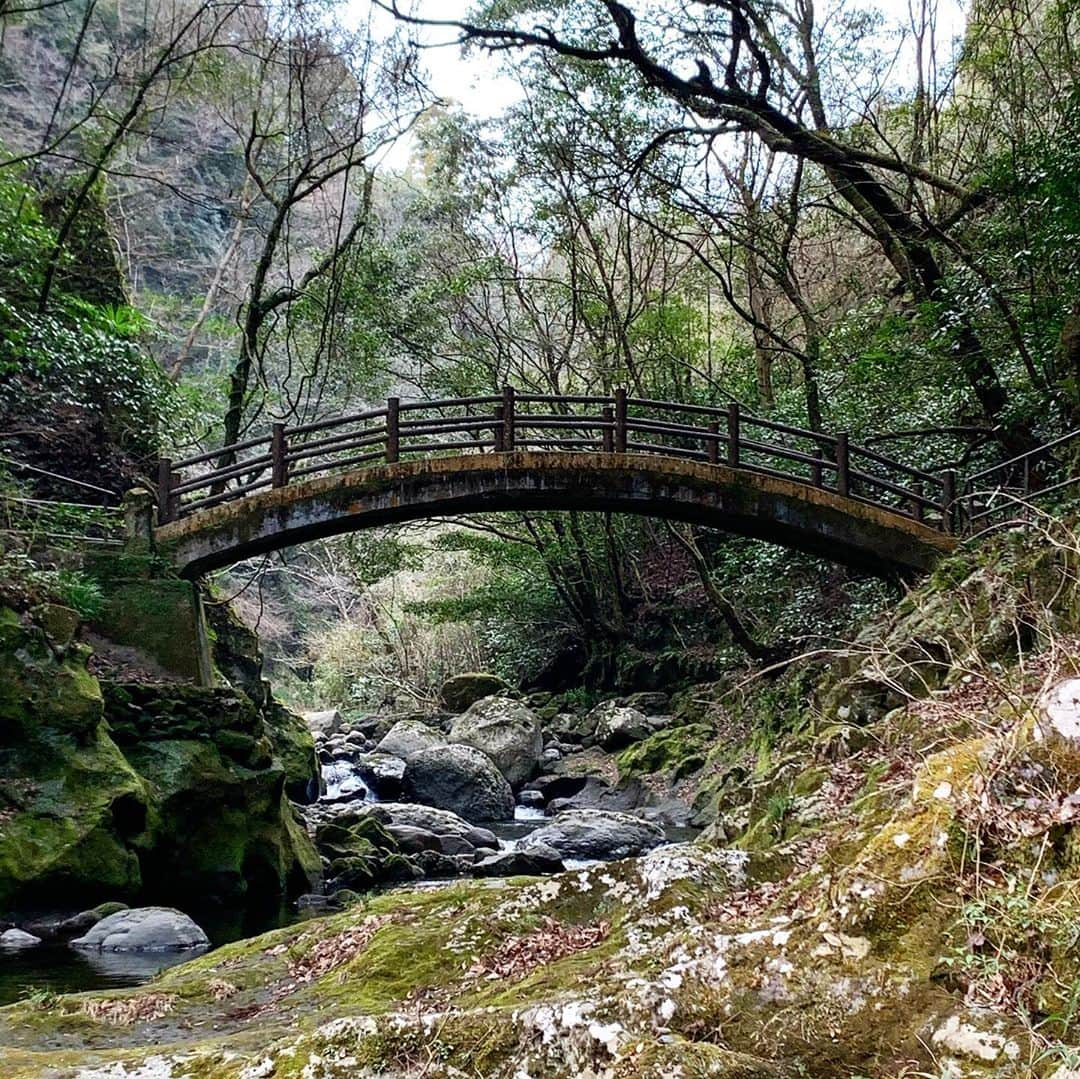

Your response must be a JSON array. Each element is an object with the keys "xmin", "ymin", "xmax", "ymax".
[{"xmin": 154, "ymin": 451, "xmax": 955, "ymax": 577}]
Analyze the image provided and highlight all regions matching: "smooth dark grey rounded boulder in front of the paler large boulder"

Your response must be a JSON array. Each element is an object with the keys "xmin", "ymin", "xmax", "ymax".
[{"xmin": 403, "ymin": 745, "xmax": 514, "ymax": 821}]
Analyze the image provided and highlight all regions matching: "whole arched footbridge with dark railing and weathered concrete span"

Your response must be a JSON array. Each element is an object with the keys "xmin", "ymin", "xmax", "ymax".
[{"xmin": 154, "ymin": 388, "xmax": 956, "ymax": 577}]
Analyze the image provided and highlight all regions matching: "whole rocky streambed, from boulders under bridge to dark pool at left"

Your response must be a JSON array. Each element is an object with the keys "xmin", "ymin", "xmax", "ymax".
[{"xmin": 0, "ymin": 675, "xmax": 697, "ymax": 1003}]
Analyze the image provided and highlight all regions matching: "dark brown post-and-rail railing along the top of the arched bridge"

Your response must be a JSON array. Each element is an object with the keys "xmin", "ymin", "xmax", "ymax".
[{"xmin": 158, "ymin": 387, "xmax": 957, "ymax": 531}]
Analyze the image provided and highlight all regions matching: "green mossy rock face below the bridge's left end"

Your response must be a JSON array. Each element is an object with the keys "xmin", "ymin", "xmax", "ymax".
[{"xmin": 0, "ymin": 607, "xmax": 320, "ymax": 912}]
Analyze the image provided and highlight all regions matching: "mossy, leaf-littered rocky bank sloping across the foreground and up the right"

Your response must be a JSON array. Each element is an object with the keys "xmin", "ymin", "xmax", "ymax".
[{"xmin": 0, "ymin": 520, "xmax": 1080, "ymax": 1079}]
